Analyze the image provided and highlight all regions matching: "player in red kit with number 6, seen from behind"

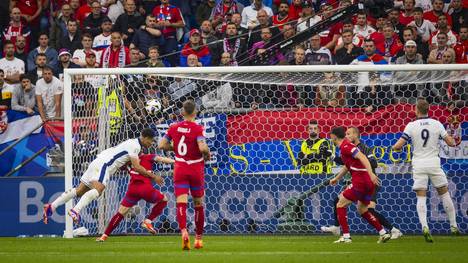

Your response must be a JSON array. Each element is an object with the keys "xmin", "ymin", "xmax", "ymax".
[{"xmin": 158, "ymin": 100, "xmax": 210, "ymax": 250}]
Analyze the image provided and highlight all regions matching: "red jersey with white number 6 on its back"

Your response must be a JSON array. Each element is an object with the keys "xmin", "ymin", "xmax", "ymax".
[{"xmin": 164, "ymin": 121, "xmax": 205, "ymax": 164}]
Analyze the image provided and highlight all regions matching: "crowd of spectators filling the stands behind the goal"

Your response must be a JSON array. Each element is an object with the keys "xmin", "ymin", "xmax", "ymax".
[{"xmin": 0, "ymin": 0, "xmax": 468, "ymax": 124}]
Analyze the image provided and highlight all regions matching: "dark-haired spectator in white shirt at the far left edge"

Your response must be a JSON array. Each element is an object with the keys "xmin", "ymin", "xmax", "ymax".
[{"xmin": 0, "ymin": 41, "xmax": 25, "ymax": 87}]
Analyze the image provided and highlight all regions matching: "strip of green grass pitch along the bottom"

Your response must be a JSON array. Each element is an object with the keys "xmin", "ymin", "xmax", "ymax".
[{"xmin": 0, "ymin": 235, "xmax": 468, "ymax": 263}]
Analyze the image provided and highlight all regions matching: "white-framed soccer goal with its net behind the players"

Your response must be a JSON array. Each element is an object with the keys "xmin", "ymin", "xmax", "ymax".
[{"xmin": 64, "ymin": 64, "xmax": 468, "ymax": 237}]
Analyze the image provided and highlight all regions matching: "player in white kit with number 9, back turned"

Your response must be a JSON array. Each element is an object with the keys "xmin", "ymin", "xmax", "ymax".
[{"xmin": 393, "ymin": 98, "xmax": 459, "ymax": 243}]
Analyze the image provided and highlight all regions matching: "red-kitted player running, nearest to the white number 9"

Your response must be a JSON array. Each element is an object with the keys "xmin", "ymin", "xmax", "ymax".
[{"xmin": 330, "ymin": 127, "xmax": 391, "ymax": 243}]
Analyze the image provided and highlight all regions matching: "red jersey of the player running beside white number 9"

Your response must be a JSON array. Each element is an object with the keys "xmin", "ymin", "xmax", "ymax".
[{"xmin": 340, "ymin": 139, "xmax": 374, "ymax": 185}]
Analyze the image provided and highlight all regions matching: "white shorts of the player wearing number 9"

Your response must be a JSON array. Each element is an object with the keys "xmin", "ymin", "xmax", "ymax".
[{"xmin": 413, "ymin": 167, "xmax": 448, "ymax": 190}]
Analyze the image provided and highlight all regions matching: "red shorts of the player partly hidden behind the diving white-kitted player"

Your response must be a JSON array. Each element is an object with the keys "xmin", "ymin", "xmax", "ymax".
[{"xmin": 120, "ymin": 181, "xmax": 164, "ymax": 207}]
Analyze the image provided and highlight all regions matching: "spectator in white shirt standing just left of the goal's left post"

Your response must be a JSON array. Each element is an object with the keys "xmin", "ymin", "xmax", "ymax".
[{"xmin": 36, "ymin": 66, "xmax": 63, "ymax": 121}]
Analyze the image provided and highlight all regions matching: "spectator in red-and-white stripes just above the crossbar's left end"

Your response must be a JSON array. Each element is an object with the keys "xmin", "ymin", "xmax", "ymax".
[{"xmin": 101, "ymin": 32, "xmax": 130, "ymax": 68}]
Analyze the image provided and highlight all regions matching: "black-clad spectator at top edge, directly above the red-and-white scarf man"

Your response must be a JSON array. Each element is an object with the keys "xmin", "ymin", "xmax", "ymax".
[{"xmin": 112, "ymin": 0, "xmax": 145, "ymax": 46}]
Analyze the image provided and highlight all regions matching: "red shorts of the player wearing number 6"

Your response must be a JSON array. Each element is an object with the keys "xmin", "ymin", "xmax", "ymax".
[{"xmin": 174, "ymin": 162, "xmax": 205, "ymax": 197}]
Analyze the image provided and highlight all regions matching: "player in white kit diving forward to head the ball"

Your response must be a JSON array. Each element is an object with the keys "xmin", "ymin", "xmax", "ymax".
[{"xmin": 43, "ymin": 128, "xmax": 163, "ymax": 224}]
